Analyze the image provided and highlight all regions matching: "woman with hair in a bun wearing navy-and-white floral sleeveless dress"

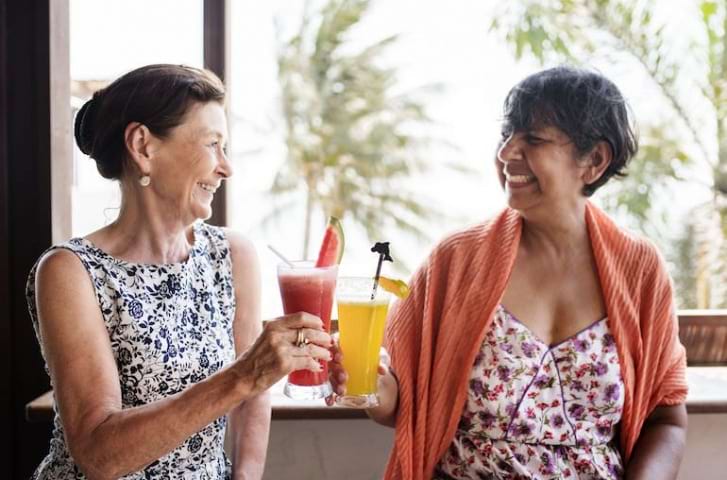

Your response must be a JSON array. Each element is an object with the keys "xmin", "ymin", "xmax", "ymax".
[{"xmin": 27, "ymin": 65, "xmax": 331, "ymax": 479}]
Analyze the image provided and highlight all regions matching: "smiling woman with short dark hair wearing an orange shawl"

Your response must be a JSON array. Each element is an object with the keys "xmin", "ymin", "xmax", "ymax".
[{"xmin": 331, "ymin": 67, "xmax": 687, "ymax": 480}]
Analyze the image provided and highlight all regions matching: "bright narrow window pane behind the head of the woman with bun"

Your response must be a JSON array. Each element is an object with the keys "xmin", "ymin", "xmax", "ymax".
[{"xmin": 70, "ymin": 0, "xmax": 203, "ymax": 236}]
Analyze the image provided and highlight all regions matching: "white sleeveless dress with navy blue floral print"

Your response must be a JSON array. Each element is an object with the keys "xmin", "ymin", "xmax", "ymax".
[{"xmin": 26, "ymin": 222, "xmax": 235, "ymax": 480}]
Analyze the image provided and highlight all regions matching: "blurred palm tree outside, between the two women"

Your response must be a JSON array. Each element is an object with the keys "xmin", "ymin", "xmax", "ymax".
[{"xmin": 270, "ymin": 0, "xmax": 450, "ymax": 257}]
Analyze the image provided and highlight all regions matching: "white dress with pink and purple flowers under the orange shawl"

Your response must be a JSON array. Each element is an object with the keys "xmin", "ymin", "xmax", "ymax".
[{"xmin": 434, "ymin": 306, "xmax": 624, "ymax": 479}]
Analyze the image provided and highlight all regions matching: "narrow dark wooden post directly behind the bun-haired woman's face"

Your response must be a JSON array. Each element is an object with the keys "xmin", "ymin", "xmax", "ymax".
[{"xmin": 203, "ymin": 0, "xmax": 227, "ymax": 226}]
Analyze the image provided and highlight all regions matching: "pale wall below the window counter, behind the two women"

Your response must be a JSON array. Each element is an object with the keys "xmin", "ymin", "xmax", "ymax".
[{"xmin": 265, "ymin": 414, "xmax": 727, "ymax": 480}]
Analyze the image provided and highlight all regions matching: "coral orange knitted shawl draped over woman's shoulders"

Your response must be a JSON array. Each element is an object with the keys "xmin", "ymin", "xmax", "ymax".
[{"xmin": 385, "ymin": 202, "xmax": 687, "ymax": 480}]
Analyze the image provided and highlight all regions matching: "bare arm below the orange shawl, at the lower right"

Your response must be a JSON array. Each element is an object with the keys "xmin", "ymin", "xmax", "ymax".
[{"xmin": 625, "ymin": 405, "xmax": 687, "ymax": 480}]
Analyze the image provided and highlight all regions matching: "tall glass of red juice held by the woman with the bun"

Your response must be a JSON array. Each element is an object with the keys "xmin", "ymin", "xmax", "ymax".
[{"xmin": 278, "ymin": 261, "xmax": 338, "ymax": 400}]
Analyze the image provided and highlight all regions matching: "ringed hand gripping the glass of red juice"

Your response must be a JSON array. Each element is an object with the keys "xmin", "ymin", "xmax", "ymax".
[{"xmin": 233, "ymin": 312, "xmax": 332, "ymax": 393}]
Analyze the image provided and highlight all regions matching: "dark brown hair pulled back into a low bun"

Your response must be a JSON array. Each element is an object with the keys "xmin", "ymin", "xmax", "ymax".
[{"xmin": 74, "ymin": 64, "xmax": 225, "ymax": 180}]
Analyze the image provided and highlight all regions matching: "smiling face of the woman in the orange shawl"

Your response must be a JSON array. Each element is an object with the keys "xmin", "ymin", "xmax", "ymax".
[{"xmin": 496, "ymin": 126, "xmax": 588, "ymax": 212}]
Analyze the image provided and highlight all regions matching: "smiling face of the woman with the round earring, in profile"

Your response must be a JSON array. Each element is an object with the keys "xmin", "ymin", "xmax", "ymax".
[{"xmin": 145, "ymin": 102, "xmax": 232, "ymax": 224}]
